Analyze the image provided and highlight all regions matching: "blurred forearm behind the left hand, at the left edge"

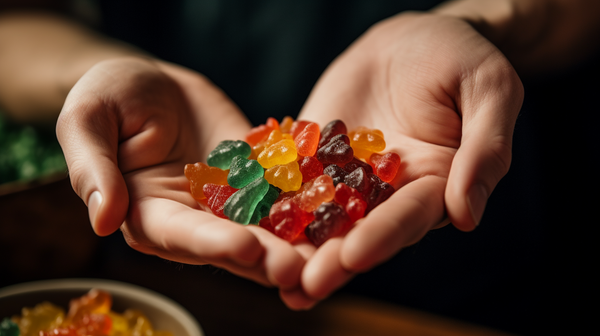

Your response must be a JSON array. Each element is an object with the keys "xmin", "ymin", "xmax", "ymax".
[{"xmin": 0, "ymin": 12, "xmax": 142, "ymax": 123}]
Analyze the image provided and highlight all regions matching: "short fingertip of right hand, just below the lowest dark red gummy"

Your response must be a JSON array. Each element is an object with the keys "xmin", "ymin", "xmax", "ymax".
[{"xmin": 302, "ymin": 237, "xmax": 355, "ymax": 300}]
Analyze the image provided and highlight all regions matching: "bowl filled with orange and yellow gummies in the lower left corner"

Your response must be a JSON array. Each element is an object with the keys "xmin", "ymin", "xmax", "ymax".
[{"xmin": 0, "ymin": 279, "xmax": 204, "ymax": 336}]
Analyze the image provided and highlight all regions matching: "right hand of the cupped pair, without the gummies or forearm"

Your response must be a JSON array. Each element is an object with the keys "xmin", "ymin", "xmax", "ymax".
[{"xmin": 282, "ymin": 13, "xmax": 523, "ymax": 308}]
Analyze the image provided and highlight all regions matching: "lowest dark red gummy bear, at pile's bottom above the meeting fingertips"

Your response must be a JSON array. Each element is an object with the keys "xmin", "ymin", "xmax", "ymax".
[{"xmin": 304, "ymin": 202, "xmax": 352, "ymax": 247}]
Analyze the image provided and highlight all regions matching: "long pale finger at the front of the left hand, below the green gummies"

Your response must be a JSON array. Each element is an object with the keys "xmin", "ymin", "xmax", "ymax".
[{"xmin": 123, "ymin": 197, "xmax": 264, "ymax": 268}]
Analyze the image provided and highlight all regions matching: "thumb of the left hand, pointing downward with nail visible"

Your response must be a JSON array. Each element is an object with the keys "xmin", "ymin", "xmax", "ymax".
[{"xmin": 56, "ymin": 90, "xmax": 129, "ymax": 236}]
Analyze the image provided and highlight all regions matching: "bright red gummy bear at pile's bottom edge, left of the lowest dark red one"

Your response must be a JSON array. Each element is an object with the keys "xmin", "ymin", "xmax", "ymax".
[{"xmin": 269, "ymin": 199, "xmax": 315, "ymax": 242}]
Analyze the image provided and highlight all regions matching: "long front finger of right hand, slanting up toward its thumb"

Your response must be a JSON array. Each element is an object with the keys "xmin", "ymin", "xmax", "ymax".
[{"xmin": 340, "ymin": 175, "xmax": 446, "ymax": 272}]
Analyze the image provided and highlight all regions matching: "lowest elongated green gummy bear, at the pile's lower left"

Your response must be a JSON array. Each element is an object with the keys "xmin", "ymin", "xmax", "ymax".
[{"xmin": 223, "ymin": 177, "xmax": 270, "ymax": 225}]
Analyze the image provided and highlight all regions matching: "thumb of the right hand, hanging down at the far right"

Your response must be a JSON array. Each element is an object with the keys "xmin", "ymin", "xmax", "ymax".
[{"xmin": 445, "ymin": 61, "xmax": 523, "ymax": 231}]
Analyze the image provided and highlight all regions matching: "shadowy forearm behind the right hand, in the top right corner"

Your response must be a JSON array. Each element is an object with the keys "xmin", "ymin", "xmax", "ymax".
[{"xmin": 433, "ymin": 0, "xmax": 600, "ymax": 74}]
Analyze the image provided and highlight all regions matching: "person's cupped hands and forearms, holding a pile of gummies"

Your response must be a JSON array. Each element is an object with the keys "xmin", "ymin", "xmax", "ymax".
[{"xmin": 0, "ymin": 0, "xmax": 600, "ymax": 318}]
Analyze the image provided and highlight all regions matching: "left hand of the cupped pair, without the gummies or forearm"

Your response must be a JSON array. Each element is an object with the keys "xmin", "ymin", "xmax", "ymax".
[{"xmin": 57, "ymin": 58, "xmax": 304, "ymax": 288}]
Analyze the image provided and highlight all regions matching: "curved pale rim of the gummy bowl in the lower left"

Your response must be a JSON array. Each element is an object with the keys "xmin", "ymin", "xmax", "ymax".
[{"xmin": 0, "ymin": 278, "xmax": 204, "ymax": 336}]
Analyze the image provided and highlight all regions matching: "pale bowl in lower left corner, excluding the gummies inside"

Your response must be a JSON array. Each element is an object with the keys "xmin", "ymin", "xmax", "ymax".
[{"xmin": 0, "ymin": 279, "xmax": 204, "ymax": 336}]
